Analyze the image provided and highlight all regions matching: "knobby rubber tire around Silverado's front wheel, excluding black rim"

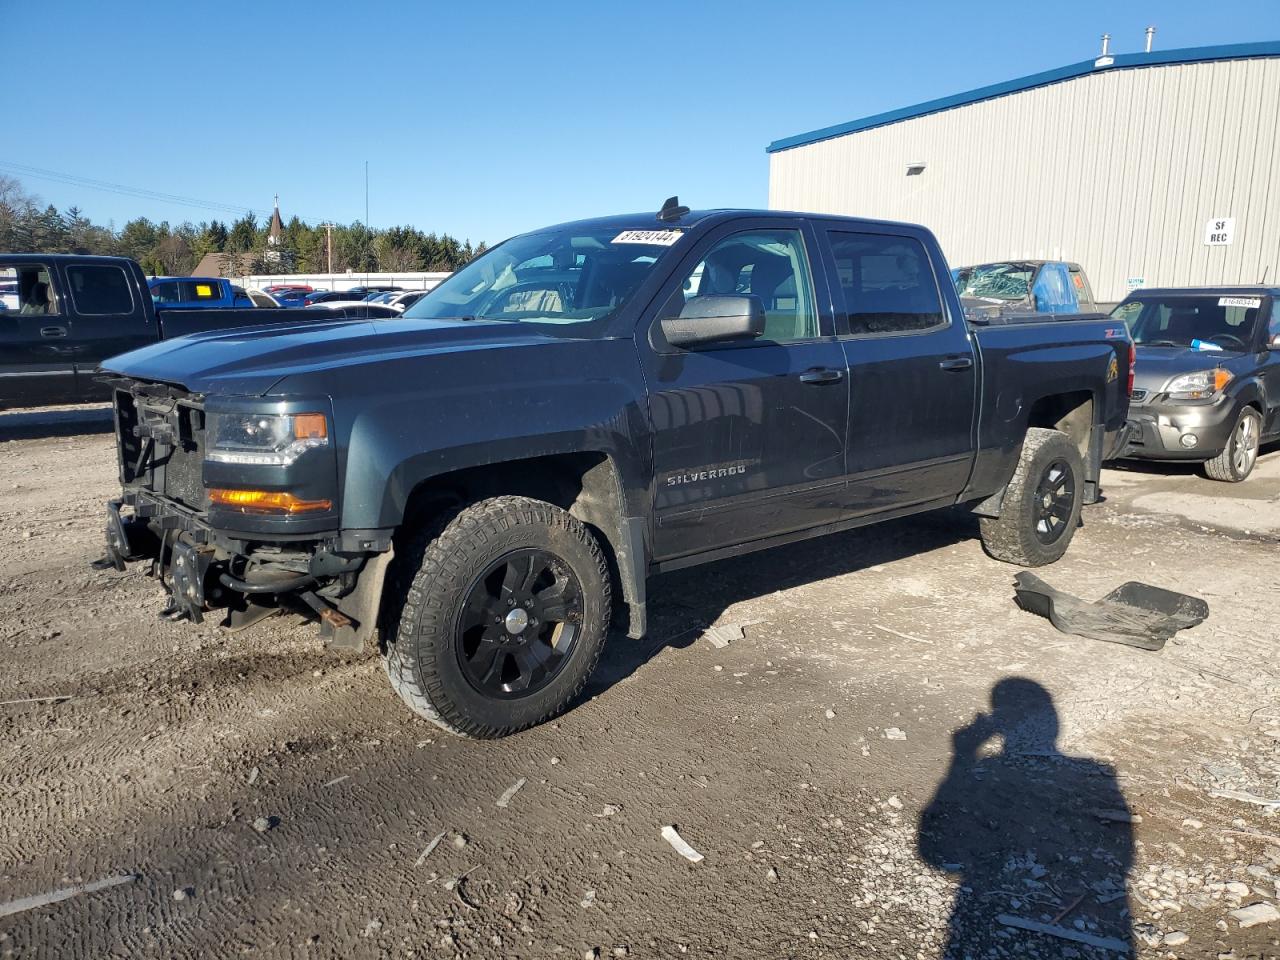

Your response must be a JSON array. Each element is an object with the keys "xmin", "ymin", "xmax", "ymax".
[{"xmin": 383, "ymin": 497, "xmax": 612, "ymax": 739}]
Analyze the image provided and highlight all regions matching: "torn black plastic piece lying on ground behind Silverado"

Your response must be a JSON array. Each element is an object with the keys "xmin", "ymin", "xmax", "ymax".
[{"xmin": 1014, "ymin": 572, "xmax": 1208, "ymax": 650}]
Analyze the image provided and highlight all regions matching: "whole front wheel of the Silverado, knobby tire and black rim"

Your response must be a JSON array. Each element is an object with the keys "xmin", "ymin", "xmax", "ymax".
[{"xmin": 384, "ymin": 497, "xmax": 611, "ymax": 739}]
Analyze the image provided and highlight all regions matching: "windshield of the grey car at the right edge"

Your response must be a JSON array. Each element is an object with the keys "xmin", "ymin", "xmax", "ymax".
[{"xmin": 1111, "ymin": 296, "xmax": 1263, "ymax": 351}]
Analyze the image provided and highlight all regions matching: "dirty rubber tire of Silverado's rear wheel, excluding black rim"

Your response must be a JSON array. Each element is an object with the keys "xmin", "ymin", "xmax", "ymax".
[{"xmin": 980, "ymin": 426, "xmax": 1084, "ymax": 567}]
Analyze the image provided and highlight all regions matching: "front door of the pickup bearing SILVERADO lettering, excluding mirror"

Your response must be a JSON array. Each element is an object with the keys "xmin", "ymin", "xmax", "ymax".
[{"xmin": 639, "ymin": 219, "xmax": 849, "ymax": 562}]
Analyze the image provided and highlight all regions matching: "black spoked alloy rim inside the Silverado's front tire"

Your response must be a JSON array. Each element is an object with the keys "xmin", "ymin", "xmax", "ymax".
[{"xmin": 456, "ymin": 549, "xmax": 585, "ymax": 699}]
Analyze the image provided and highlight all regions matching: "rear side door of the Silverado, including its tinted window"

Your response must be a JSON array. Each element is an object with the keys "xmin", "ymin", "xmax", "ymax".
[{"xmin": 826, "ymin": 225, "xmax": 978, "ymax": 516}]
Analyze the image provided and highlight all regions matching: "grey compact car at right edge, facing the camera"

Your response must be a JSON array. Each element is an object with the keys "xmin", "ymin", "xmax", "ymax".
[{"xmin": 1111, "ymin": 287, "xmax": 1280, "ymax": 483}]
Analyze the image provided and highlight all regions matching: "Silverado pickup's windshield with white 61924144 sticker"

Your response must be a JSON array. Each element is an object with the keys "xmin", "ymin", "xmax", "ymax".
[{"xmin": 403, "ymin": 229, "xmax": 680, "ymax": 324}]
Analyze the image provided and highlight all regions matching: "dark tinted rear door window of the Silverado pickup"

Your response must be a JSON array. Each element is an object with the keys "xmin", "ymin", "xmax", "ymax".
[{"xmin": 829, "ymin": 233, "xmax": 947, "ymax": 335}]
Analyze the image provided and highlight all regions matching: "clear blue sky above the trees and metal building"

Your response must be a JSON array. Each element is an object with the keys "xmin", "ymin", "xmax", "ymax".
[{"xmin": 0, "ymin": 0, "xmax": 1280, "ymax": 243}]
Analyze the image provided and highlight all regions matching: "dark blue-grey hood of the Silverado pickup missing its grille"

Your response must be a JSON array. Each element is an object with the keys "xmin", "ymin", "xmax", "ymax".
[{"xmin": 101, "ymin": 320, "xmax": 581, "ymax": 397}]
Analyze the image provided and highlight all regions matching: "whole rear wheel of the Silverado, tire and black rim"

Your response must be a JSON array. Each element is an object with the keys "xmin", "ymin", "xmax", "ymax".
[{"xmin": 980, "ymin": 426, "xmax": 1084, "ymax": 567}]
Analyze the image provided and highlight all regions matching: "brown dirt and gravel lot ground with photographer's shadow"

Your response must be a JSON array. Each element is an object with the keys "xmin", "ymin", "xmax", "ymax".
[{"xmin": 0, "ymin": 419, "xmax": 1280, "ymax": 960}]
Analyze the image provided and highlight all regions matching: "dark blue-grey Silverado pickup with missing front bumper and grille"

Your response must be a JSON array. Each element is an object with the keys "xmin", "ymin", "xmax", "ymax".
[{"xmin": 104, "ymin": 207, "xmax": 1132, "ymax": 737}]
